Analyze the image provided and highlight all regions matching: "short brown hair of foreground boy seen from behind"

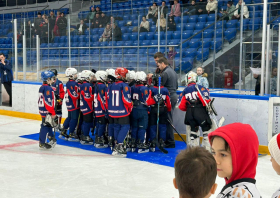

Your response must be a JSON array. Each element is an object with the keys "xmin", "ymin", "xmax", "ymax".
[{"xmin": 174, "ymin": 147, "xmax": 217, "ymax": 198}]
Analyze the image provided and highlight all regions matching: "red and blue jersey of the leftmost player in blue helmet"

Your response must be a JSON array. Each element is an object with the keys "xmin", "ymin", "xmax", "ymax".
[{"xmin": 38, "ymin": 84, "xmax": 55, "ymax": 117}]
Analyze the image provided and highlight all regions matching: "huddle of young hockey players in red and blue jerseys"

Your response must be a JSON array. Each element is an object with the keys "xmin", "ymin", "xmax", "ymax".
[{"xmin": 38, "ymin": 67, "xmax": 174, "ymax": 156}]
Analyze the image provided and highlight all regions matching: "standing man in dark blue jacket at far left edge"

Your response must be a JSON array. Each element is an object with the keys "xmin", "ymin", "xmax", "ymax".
[{"xmin": 0, "ymin": 53, "xmax": 13, "ymax": 106}]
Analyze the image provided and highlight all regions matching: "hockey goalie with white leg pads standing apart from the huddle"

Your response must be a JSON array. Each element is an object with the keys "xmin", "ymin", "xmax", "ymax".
[{"xmin": 178, "ymin": 71, "xmax": 212, "ymax": 151}]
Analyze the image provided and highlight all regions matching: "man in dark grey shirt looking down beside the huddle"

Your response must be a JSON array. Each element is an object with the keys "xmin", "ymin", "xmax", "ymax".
[{"xmin": 156, "ymin": 57, "xmax": 178, "ymax": 148}]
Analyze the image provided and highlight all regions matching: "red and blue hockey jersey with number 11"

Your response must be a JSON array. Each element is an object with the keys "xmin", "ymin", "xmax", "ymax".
[{"xmin": 106, "ymin": 81, "xmax": 132, "ymax": 118}]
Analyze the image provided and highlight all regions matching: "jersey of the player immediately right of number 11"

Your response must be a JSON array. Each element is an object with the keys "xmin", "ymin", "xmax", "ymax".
[{"xmin": 131, "ymin": 84, "xmax": 149, "ymax": 109}]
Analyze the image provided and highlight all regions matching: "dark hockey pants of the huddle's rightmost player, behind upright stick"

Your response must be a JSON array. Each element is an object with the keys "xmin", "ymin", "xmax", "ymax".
[{"xmin": 149, "ymin": 107, "xmax": 167, "ymax": 141}]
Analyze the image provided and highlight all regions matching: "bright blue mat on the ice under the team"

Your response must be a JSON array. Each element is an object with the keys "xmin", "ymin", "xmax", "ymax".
[{"xmin": 20, "ymin": 133, "xmax": 186, "ymax": 167}]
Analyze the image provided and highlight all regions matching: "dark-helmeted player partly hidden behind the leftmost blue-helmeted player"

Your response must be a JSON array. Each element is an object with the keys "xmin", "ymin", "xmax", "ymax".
[{"xmin": 50, "ymin": 69, "xmax": 65, "ymax": 130}]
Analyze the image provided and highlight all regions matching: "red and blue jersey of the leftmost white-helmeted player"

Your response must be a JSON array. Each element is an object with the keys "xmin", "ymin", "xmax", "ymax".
[{"xmin": 65, "ymin": 80, "xmax": 80, "ymax": 111}]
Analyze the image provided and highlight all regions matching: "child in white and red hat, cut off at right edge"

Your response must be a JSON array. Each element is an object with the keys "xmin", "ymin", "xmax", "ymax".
[{"xmin": 268, "ymin": 134, "xmax": 280, "ymax": 198}]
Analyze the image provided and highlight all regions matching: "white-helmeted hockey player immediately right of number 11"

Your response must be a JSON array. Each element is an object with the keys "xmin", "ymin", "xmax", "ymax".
[{"xmin": 131, "ymin": 71, "xmax": 149, "ymax": 153}]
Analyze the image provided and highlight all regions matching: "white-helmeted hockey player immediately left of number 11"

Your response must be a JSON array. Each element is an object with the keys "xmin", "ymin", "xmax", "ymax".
[{"xmin": 94, "ymin": 71, "xmax": 108, "ymax": 148}]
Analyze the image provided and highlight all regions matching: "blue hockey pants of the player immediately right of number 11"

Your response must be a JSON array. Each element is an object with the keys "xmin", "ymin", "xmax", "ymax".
[{"xmin": 131, "ymin": 108, "xmax": 148, "ymax": 142}]
